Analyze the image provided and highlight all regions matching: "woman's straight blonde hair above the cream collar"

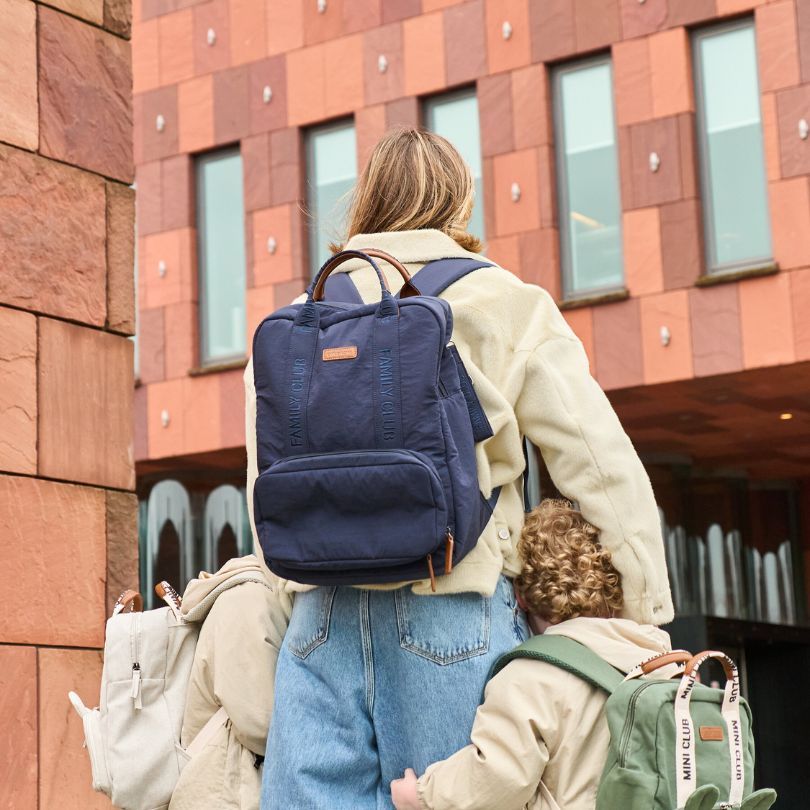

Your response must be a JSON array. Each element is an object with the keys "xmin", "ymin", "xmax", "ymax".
[{"xmin": 331, "ymin": 127, "xmax": 483, "ymax": 253}]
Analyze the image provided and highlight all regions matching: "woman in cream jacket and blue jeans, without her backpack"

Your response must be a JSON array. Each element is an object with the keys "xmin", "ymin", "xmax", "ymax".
[{"xmin": 245, "ymin": 129, "xmax": 672, "ymax": 810}]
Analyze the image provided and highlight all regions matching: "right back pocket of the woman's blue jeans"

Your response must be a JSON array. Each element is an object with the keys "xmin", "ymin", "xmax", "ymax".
[{"xmin": 395, "ymin": 588, "xmax": 492, "ymax": 666}]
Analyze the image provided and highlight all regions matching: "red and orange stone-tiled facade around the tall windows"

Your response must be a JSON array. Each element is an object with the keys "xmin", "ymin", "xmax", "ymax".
[{"xmin": 133, "ymin": 0, "xmax": 810, "ymax": 468}]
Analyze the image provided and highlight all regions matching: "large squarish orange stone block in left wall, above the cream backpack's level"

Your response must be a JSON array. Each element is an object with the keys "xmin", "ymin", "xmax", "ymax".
[{"xmin": 0, "ymin": 476, "xmax": 106, "ymax": 648}]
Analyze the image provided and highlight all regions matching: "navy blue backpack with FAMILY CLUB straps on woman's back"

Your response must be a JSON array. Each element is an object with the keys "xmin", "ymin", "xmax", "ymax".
[{"xmin": 253, "ymin": 250, "xmax": 492, "ymax": 588}]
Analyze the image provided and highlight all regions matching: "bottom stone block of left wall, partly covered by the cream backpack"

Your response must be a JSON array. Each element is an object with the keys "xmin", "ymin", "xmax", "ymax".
[{"xmin": 39, "ymin": 649, "xmax": 110, "ymax": 810}]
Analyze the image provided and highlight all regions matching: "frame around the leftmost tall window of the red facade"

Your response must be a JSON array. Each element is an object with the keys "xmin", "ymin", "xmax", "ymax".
[{"xmin": 192, "ymin": 143, "xmax": 248, "ymax": 368}]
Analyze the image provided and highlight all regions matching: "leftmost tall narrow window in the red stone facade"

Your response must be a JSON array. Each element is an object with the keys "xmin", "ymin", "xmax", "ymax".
[{"xmin": 197, "ymin": 149, "xmax": 247, "ymax": 364}]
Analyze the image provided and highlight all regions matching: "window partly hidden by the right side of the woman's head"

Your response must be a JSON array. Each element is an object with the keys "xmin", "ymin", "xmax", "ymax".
[{"xmin": 422, "ymin": 88, "xmax": 484, "ymax": 239}]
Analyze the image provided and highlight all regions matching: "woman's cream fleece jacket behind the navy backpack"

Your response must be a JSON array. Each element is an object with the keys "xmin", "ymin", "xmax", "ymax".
[{"xmin": 245, "ymin": 230, "xmax": 673, "ymax": 624}]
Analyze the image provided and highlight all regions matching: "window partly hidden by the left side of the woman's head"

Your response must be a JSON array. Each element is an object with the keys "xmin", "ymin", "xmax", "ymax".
[{"xmin": 307, "ymin": 121, "xmax": 357, "ymax": 275}]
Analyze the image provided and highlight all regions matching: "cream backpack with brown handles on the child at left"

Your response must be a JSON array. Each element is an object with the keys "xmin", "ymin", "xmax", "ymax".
[{"xmin": 68, "ymin": 572, "xmax": 267, "ymax": 810}]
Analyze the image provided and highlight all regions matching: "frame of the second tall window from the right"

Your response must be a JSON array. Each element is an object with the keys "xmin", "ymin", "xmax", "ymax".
[{"xmin": 551, "ymin": 52, "xmax": 627, "ymax": 302}]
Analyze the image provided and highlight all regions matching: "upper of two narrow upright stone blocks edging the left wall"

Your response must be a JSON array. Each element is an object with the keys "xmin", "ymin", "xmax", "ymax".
[{"xmin": 106, "ymin": 183, "xmax": 135, "ymax": 335}]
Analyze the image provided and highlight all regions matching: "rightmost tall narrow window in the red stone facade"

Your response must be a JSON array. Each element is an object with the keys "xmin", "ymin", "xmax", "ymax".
[{"xmin": 693, "ymin": 20, "xmax": 771, "ymax": 272}]
